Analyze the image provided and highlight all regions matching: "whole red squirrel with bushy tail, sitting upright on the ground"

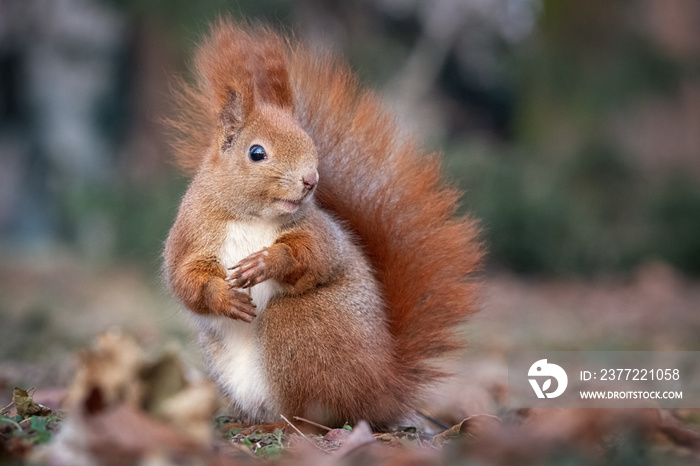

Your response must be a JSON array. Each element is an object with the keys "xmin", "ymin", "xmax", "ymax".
[{"xmin": 164, "ymin": 19, "xmax": 483, "ymax": 428}]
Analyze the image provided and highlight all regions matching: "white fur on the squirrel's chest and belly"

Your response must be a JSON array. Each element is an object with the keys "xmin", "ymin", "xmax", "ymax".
[{"xmin": 197, "ymin": 221, "xmax": 281, "ymax": 418}]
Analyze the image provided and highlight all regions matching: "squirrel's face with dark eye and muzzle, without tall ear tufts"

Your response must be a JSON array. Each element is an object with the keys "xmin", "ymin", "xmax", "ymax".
[{"xmin": 206, "ymin": 93, "xmax": 318, "ymax": 220}]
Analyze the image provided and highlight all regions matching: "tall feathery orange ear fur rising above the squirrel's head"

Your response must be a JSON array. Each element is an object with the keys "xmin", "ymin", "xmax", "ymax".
[{"xmin": 166, "ymin": 18, "xmax": 294, "ymax": 174}]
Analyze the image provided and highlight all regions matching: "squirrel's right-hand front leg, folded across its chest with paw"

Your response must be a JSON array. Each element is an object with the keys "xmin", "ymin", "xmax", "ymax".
[{"xmin": 226, "ymin": 232, "xmax": 332, "ymax": 294}]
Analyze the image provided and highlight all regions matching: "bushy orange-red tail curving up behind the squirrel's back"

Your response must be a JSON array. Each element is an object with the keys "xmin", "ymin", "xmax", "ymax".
[{"xmin": 290, "ymin": 47, "xmax": 483, "ymax": 387}]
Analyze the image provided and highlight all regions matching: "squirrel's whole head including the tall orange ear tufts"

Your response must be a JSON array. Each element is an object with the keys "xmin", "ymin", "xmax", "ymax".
[{"xmin": 197, "ymin": 22, "xmax": 318, "ymax": 220}]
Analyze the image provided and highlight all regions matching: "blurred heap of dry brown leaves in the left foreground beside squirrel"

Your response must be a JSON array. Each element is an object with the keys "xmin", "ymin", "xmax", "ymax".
[{"xmin": 35, "ymin": 332, "xmax": 216, "ymax": 464}]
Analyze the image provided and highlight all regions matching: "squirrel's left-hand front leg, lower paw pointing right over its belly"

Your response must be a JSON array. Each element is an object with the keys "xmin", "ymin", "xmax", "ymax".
[{"xmin": 173, "ymin": 258, "xmax": 255, "ymax": 322}]
